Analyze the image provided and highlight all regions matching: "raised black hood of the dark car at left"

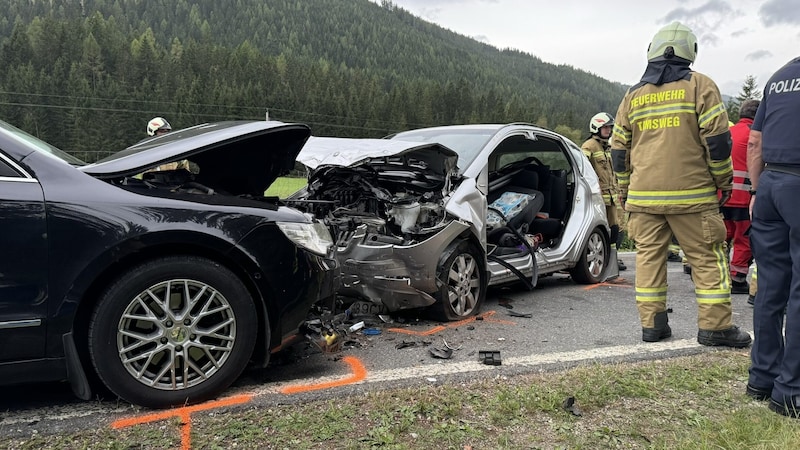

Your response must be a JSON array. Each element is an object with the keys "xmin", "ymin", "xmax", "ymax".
[{"xmin": 79, "ymin": 121, "xmax": 311, "ymax": 195}]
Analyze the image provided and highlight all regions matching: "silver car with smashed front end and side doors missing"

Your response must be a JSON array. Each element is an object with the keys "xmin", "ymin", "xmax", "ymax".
[{"xmin": 290, "ymin": 123, "xmax": 618, "ymax": 320}]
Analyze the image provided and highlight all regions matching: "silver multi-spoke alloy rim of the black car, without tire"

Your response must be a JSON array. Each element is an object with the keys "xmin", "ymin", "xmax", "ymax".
[{"xmin": 117, "ymin": 279, "xmax": 236, "ymax": 390}]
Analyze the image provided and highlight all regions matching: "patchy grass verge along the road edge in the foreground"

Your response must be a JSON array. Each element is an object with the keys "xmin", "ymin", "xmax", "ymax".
[{"xmin": 6, "ymin": 350, "xmax": 800, "ymax": 449}]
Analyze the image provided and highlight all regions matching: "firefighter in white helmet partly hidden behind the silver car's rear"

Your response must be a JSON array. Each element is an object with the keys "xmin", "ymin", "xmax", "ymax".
[{"xmin": 581, "ymin": 112, "xmax": 628, "ymax": 270}]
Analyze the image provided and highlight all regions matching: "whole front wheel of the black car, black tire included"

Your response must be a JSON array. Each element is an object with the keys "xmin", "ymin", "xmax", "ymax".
[{"xmin": 88, "ymin": 256, "xmax": 258, "ymax": 408}]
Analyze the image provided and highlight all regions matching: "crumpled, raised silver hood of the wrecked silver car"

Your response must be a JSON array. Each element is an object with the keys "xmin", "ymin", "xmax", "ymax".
[{"xmin": 297, "ymin": 137, "xmax": 458, "ymax": 175}]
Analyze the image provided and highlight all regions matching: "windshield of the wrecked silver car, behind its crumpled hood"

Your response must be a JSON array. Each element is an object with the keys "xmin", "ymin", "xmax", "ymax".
[{"xmin": 391, "ymin": 128, "xmax": 497, "ymax": 171}]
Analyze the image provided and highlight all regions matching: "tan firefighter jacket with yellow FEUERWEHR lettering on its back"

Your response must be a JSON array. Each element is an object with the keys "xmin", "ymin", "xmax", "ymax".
[{"xmin": 611, "ymin": 71, "xmax": 733, "ymax": 214}]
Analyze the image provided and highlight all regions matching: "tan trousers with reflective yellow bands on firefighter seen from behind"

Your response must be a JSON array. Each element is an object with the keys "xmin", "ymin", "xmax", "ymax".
[{"xmin": 628, "ymin": 210, "xmax": 732, "ymax": 331}]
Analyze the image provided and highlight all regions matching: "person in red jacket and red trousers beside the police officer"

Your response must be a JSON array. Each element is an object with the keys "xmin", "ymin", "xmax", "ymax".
[{"xmin": 722, "ymin": 100, "xmax": 761, "ymax": 294}]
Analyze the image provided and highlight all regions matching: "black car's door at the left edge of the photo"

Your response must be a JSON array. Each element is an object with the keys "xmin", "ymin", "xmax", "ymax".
[{"xmin": 0, "ymin": 151, "xmax": 47, "ymax": 363}]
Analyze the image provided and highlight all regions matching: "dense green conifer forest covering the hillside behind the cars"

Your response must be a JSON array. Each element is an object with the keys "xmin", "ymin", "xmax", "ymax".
[{"xmin": 0, "ymin": 0, "xmax": 625, "ymax": 162}]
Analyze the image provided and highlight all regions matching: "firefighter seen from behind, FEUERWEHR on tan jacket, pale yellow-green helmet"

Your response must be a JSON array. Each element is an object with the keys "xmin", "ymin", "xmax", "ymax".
[{"xmin": 611, "ymin": 22, "xmax": 751, "ymax": 348}]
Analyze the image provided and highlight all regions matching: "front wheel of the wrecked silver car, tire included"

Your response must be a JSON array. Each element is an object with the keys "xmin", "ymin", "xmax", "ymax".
[{"xmin": 430, "ymin": 240, "xmax": 487, "ymax": 321}]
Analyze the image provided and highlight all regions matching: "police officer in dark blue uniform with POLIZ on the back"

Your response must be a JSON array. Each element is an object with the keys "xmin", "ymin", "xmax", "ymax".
[{"xmin": 746, "ymin": 57, "xmax": 800, "ymax": 418}]
